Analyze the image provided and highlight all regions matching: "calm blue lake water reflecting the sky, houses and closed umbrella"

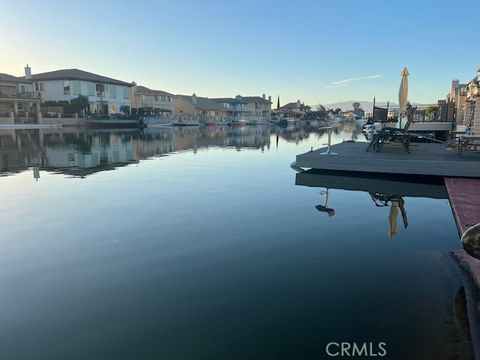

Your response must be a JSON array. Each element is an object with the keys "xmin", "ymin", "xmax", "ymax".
[{"xmin": 0, "ymin": 126, "xmax": 468, "ymax": 359}]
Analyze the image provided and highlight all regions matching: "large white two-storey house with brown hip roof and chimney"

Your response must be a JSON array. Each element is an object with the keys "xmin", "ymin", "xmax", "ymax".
[{"xmin": 24, "ymin": 65, "xmax": 133, "ymax": 114}]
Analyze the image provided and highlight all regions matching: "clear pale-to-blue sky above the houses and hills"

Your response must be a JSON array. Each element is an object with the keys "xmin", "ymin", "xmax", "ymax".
[{"xmin": 0, "ymin": 0, "xmax": 480, "ymax": 105}]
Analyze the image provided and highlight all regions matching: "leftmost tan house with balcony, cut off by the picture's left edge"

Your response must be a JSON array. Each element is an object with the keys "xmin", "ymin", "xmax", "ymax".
[{"xmin": 0, "ymin": 69, "xmax": 40, "ymax": 124}]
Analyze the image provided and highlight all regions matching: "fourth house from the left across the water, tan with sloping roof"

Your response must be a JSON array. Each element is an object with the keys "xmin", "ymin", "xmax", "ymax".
[{"xmin": 174, "ymin": 94, "xmax": 226, "ymax": 117}]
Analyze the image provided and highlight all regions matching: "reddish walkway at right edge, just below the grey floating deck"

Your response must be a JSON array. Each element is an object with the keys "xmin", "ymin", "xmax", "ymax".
[{"xmin": 445, "ymin": 178, "xmax": 480, "ymax": 236}]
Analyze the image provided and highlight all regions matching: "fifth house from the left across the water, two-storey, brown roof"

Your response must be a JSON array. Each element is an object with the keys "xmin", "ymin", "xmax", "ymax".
[{"xmin": 212, "ymin": 94, "xmax": 272, "ymax": 121}]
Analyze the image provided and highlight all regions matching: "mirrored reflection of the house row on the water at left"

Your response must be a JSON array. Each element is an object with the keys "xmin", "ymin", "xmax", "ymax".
[{"xmin": 0, "ymin": 126, "xmax": 271, "ymax": 180}]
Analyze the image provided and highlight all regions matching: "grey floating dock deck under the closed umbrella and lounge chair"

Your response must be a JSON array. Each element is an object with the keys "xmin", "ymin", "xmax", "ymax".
[{"xmin": 296, "ymin": 142, "xmax": 480, "ymax": 177}]
